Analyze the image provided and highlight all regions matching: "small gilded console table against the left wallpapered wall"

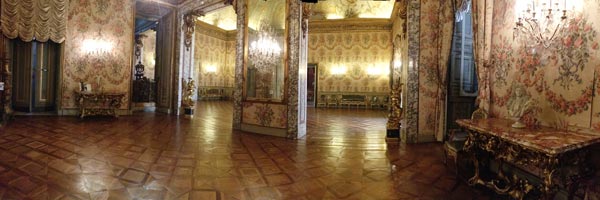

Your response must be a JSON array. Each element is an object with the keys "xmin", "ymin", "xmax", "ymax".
[{"xmin": 75, "ymin": 91, "xmax": 125, "ymax": 118}]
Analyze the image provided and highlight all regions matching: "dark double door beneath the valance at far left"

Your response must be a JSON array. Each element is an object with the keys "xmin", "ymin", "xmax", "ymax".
[{"xmin": 11, "ymin": 40, "xmax": 60, "ymax": 113}]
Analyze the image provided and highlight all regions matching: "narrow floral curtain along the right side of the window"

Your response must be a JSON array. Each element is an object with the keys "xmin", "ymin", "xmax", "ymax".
[{"xmin": 471, "ymin": 0, "xmax": 494, "ymax": 112}]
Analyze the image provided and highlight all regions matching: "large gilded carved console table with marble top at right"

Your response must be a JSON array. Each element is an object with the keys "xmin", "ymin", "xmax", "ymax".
[{"xmin": 456, "ymin": 118, "xmax": 600, "ymax": 199}]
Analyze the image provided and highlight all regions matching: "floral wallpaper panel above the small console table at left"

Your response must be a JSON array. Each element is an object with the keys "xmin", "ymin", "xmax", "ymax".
[{"xmin": 61, "ymin": 0, "xmax": 135, "ymax": 109}]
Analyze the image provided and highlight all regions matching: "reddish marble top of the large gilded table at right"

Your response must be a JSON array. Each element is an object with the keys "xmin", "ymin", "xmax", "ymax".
[{"xmin": 456, "ymin": 118, "xmax": 600, "ymax": 156}]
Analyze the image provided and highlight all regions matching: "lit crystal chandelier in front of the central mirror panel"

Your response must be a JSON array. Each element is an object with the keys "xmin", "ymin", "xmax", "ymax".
[{"xmin": 248, "ymin": 21, "xmax": 281, "ymax": 72}]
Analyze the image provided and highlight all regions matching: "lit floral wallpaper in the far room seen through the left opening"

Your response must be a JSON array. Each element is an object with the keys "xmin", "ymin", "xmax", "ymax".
[{"xmin": 194, "ymin": 31, "xmax": 235, "ymax": 87}]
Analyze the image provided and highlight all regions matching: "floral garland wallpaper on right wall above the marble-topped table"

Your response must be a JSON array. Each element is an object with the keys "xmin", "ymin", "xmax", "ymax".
[{"xmin": 490, "ymin": 0, "xmax": 600, "ymax": 130}]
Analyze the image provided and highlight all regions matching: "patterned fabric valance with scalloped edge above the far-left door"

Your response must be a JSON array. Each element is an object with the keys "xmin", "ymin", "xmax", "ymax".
[{"xmin": 0, "ymin": 0, "xmax": 69, "ymax": 43}]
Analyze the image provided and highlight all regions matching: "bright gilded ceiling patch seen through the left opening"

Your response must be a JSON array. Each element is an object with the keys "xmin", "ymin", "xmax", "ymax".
[{"xmin": 198, "ymin": 6, "xmax": 237, "ymax": 31}]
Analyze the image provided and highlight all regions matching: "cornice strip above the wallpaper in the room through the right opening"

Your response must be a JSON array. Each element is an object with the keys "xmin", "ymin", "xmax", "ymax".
[{"xmin": 308, "ymin": 19, "xmax": 392, "ymax": 33}]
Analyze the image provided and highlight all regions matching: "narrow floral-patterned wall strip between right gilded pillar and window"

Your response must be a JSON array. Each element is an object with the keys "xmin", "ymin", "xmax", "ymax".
[{"xmin": 418, "ymin": 0, "xmax": 454, "ymax": 142}]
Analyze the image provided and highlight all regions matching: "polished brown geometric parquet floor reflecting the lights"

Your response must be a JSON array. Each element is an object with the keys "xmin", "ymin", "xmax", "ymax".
[{"xmin": 0, "ymin": 102, "xmax": 492, "ymax": 199}]
